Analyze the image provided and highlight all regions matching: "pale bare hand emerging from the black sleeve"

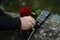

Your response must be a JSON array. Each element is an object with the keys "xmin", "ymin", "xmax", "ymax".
[{"xmin": 20, "ymin": 16, "xmax": 35, "ymax": 30}]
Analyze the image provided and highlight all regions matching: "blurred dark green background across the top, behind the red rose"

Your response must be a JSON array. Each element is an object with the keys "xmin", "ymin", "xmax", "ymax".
[{"xmin": 1, "ymin": 0, "xmax": 60, "ymax": 14}]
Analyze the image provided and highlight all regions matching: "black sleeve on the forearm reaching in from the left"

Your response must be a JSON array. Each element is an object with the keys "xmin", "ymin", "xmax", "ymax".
[{"xmin": 0, "ymin": 16, "xmax": 21, "ymax": 30}]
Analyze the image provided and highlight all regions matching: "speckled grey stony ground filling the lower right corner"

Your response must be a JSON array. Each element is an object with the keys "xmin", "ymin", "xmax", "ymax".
[{"xmin": 30, "ymin": 20, "xmax": 60, "ymax": 40}]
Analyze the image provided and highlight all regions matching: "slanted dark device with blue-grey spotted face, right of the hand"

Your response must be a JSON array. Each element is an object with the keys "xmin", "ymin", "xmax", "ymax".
[{"xmin": 34, "ymin": 11, "xmax": 50, "ymax": 29}]
